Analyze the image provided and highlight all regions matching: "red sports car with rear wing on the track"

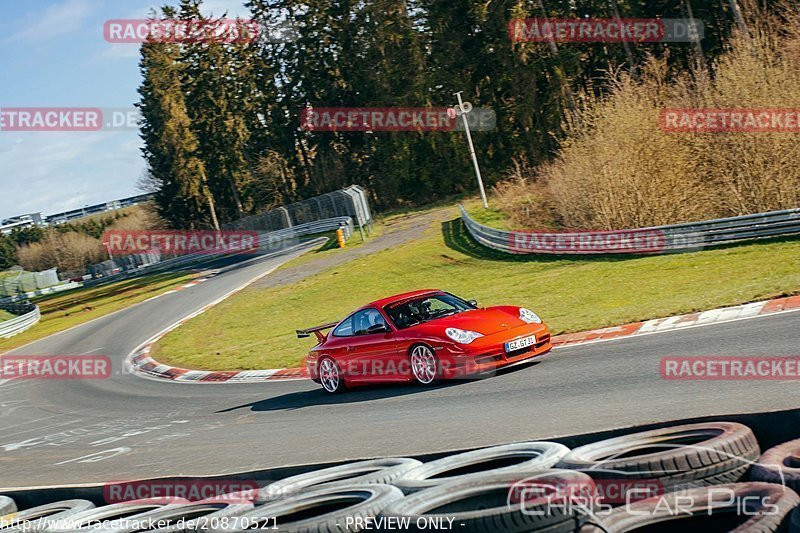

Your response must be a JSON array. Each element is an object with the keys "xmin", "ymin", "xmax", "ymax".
[{"xmin": 297, "ymin": 290, "xmax": 552, "ymax": 393}]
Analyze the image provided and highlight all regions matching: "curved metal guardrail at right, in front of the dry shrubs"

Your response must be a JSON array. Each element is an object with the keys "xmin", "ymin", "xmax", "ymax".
[{"xmin": 459, "ymin": 206, "xmax": 800, "ymax": 255}]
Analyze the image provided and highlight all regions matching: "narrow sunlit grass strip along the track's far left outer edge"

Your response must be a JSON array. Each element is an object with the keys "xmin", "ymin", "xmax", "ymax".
[{"xmin": 0, "ymin": 272, "xmax": 197, "ymax": 353}]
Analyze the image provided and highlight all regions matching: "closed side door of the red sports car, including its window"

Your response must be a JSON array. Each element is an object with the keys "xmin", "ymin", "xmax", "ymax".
[{"xmin": 347, "ymin": 307, "xmax": 399, "ymax": 381}]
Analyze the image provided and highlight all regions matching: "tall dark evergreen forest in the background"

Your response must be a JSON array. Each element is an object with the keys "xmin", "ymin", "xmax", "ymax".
[{"xmin": 139, "ymin": 0, "xmax": 756, "ymax": 227}]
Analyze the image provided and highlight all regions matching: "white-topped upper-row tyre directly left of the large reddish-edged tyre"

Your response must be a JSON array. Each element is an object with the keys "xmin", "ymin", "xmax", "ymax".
[{"xmin": 392, "ymin": 442, "xmax": 569, "ymax": 494}]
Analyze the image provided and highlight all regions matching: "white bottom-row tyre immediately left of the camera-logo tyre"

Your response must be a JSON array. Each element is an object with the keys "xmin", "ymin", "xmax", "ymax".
[{"xmin": 209, "ymin": 484, "xmax": 403, "ymax": 533}]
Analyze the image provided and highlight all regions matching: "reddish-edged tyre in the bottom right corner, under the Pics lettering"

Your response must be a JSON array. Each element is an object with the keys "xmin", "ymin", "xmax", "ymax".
[{"xmin": 580, "ymin": 482, "xmax": 800, "ymax": 533}]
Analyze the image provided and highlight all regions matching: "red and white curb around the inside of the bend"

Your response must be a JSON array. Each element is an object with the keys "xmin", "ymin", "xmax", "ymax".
[{"xmin": 129, "ymin": 294, "xmax": 800, "ymax": 383}]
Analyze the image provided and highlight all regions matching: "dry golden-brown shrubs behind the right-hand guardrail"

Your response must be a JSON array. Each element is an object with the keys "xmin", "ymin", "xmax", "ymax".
[{"xmin": 495, "ymin": 5, "xmax": 800, "ymax": 229}]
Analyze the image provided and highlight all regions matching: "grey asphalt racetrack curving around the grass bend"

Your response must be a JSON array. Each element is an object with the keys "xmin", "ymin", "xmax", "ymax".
[{"xmin": 0, "ymin": 244, "xmax": 800, "ymax": 488}]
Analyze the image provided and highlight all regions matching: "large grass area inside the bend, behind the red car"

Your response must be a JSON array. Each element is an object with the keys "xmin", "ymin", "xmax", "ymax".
[{"xmin": 153, "ymin": 214, "xmax": 800, "ymax": 370}]
